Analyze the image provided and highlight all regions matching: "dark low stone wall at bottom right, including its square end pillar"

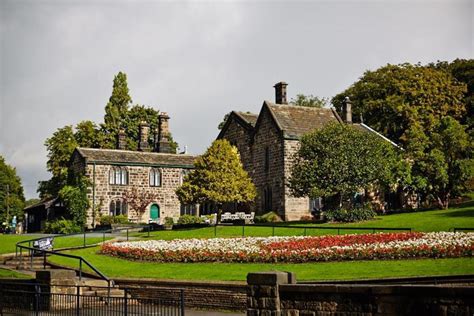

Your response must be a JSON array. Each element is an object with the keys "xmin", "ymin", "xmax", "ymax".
[{"xmin": 247, "ymin": 272, "xmax": 474, "ymax": 316}]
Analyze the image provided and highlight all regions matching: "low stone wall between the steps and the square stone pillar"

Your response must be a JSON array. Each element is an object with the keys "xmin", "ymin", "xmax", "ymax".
[{"xmin": 114, "ymin": 279, "xmax": 247, "ymax": 311}]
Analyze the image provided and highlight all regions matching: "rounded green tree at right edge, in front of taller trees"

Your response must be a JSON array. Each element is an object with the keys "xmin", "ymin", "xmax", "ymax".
[{"xmin": 407, "ymin": 116, "xmax": 474, "ymax": 209}]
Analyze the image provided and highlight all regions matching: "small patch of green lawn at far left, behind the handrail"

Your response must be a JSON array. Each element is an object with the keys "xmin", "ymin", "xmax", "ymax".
[{"xmin": 0, "ymin": 235, "xmax": 110, "ymax": 254}]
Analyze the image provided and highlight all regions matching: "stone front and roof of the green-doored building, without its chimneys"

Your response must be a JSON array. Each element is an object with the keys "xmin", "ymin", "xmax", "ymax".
[{"xmin": 71, "ymin": 148, "xmax": 195, "ymax": 227}]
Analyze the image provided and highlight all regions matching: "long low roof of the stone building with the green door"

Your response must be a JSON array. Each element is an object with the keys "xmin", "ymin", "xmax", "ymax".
[{"xmin": 73, "ymin": 147, "xmax": 197, "ymax": 168}]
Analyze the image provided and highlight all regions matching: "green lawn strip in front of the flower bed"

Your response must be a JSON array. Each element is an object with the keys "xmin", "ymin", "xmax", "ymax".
[{"xmin": 49, "ymin": 247, "xmax": 474, "ymax": 281}]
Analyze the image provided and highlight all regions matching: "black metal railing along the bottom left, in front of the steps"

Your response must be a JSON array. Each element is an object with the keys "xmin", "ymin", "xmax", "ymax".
[{"xmin": 0, "ymin": 282, "xmax": 185, "ymax": 316}]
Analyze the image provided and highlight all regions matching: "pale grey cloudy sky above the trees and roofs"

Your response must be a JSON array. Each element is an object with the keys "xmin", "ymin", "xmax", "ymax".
[{"xmin": 0, "ymin": 0, "xmax": 474, "ymax": 198}]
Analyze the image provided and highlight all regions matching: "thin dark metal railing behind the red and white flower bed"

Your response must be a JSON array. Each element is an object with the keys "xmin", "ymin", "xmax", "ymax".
[{"xmin": 214, "ymin": 224, "xmax": 412, "ymax": 237}]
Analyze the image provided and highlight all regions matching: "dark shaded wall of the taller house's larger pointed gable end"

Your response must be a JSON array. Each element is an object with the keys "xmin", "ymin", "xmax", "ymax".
[{"xmin": 252, "ymin": 108, "xmax": 285, "ymax": 218}]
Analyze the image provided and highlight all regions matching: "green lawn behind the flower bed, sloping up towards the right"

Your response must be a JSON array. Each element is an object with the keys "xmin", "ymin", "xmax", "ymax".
[{"xmin": 133, "ymin": 202, "xmax": 474, "ymax": 240}]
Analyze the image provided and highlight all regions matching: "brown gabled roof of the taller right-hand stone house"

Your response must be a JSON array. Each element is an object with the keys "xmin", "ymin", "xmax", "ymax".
[{"xmin": 263, "ymin": 101, "xmax": 342, "ymax": 139}]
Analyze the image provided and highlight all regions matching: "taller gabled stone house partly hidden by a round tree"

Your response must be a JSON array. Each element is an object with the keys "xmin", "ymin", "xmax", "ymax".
[{"xmin": 217, "ymin": 82, "xmax": 400, "ymax": 220}]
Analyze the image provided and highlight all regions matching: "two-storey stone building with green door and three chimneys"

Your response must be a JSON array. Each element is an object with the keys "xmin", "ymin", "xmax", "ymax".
[{"xmin": 71, "ymin": 113, "xmax": 196, "ymax": 226}]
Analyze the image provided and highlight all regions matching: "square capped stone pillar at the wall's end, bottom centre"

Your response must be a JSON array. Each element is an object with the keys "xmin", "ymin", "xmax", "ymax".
[{"xmin": 247, "ymin": 271, "xmax": 296, "ymax": 316}]
